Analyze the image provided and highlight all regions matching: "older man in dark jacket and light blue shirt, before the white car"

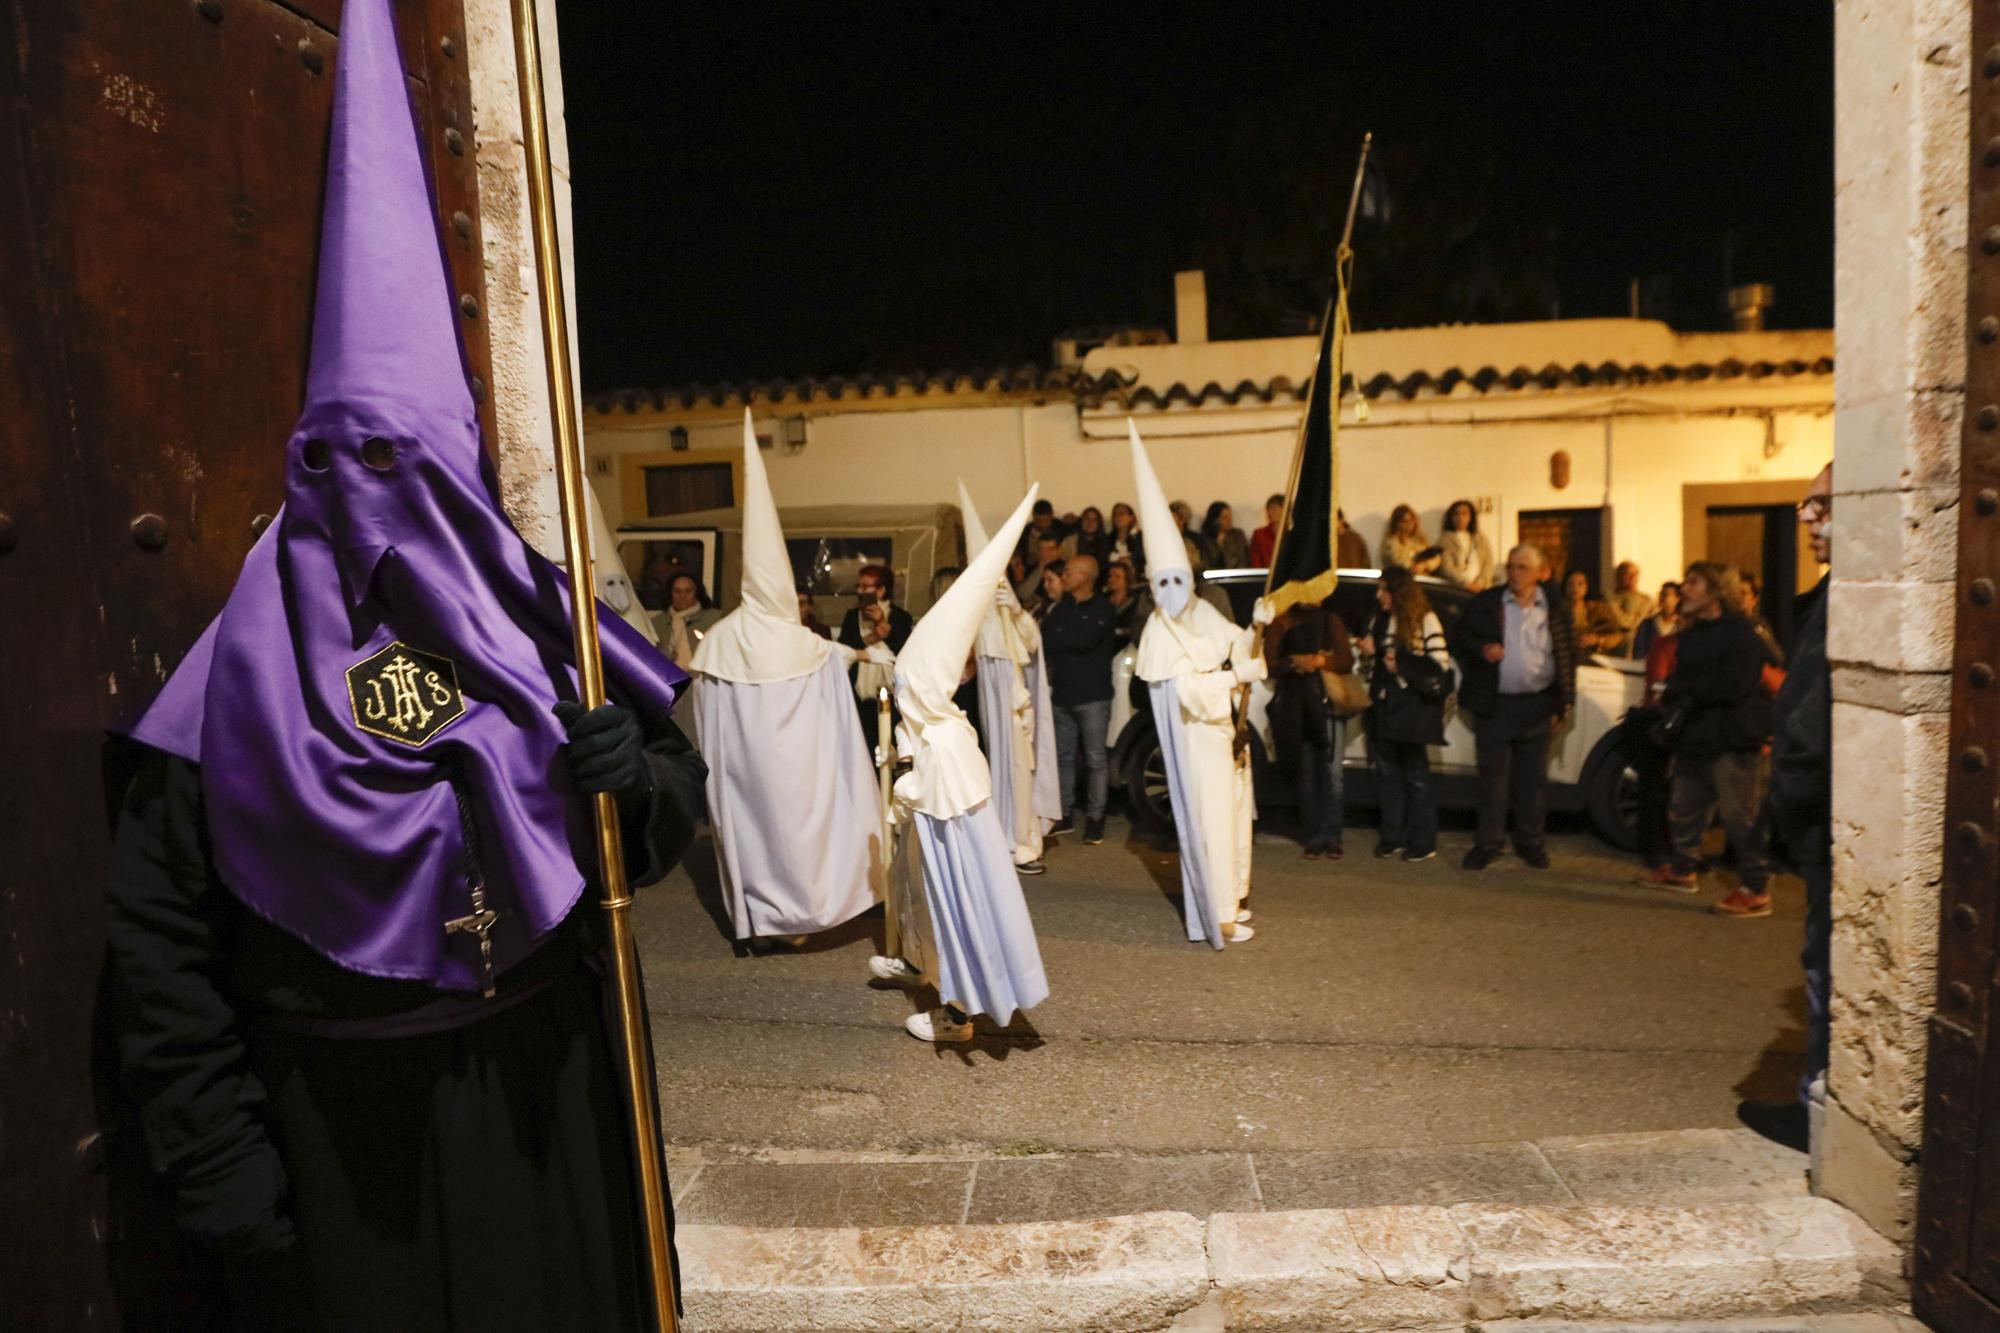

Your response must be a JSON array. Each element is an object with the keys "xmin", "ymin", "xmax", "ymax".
[{"xmin": 1452, "ymin": 546, "xmax": 1576, "ymax": 871}]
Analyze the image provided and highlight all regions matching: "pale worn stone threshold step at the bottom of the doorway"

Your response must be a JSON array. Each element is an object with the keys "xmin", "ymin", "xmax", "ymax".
[{"xmin": 680, "ymin": 1199, "xmax": 1906, "ymax": 1333}]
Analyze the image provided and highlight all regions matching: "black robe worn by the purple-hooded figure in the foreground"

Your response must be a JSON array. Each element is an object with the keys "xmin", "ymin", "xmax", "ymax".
[{"xmin": 106, "ymin": 727, "xmax": 706, "ymax": 1333}]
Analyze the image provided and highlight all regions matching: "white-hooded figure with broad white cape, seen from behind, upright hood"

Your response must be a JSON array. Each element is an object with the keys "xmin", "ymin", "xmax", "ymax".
[{"xmin": 692, "ymin": 412, "xmax": 884, "ymax": 941}]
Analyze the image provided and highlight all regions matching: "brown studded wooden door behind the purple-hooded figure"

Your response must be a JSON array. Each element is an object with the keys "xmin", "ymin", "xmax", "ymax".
[{"xmin": 0, "ymin": 0, "xmax": 492, "ymax": 1329}]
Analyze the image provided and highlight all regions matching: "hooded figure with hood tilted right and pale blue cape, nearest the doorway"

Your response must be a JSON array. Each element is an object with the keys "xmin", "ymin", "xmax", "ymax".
[{"xmin": 868, "ymin": 490, "xmax": 1048, "ymax": 1041}]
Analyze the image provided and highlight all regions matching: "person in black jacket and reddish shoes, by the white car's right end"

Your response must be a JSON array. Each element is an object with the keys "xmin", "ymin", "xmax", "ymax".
[{"xmin": 1640, "ymin": 560, "xmax": 1772, "ymax": 917}]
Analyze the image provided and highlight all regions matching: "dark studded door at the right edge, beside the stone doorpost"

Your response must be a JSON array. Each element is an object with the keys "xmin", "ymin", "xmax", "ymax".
[{"xmin": 1912, "ymin": 4, "xmax": 2000, "ymax": 1333}]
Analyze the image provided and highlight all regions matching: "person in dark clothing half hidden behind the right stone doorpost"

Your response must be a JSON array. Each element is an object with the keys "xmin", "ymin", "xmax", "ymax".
[{"xmin": 1736, "ymin": 464, "xmax": 1834, "ymax": 1151}]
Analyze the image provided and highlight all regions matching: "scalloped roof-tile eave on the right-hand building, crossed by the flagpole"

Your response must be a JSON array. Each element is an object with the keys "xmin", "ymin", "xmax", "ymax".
[{"xmin": 1076, "ymin": 356, "xmax": 1834, "ymax": 410}]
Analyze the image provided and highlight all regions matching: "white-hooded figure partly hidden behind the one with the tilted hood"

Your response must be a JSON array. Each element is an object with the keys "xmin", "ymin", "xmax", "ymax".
[{"xmin": 958, "ymin": 478, "xmax": 1062, "ymax": 860}]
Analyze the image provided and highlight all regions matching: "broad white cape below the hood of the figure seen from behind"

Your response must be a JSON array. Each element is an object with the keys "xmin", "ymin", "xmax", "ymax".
[{"xmin": 694, "ymin": 652, "xmax": 884, "ymax": 939}]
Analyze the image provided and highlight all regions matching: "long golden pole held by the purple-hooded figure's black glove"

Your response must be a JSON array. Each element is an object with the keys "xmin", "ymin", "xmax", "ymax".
[{"xmin": 512, "ymin": 0, "xmax": 680, "ymax": 1333}]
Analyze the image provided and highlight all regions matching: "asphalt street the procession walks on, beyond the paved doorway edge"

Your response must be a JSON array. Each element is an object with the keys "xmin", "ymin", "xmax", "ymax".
[{"xmin": 636, "ymin": 817, "xmax": 1804, "ymax": 1157}]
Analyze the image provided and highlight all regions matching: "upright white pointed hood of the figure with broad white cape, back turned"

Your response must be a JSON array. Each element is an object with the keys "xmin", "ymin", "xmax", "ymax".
[{"xmin": 692, "ymin": 408, "xmax": 832, "ymax": 685}]
